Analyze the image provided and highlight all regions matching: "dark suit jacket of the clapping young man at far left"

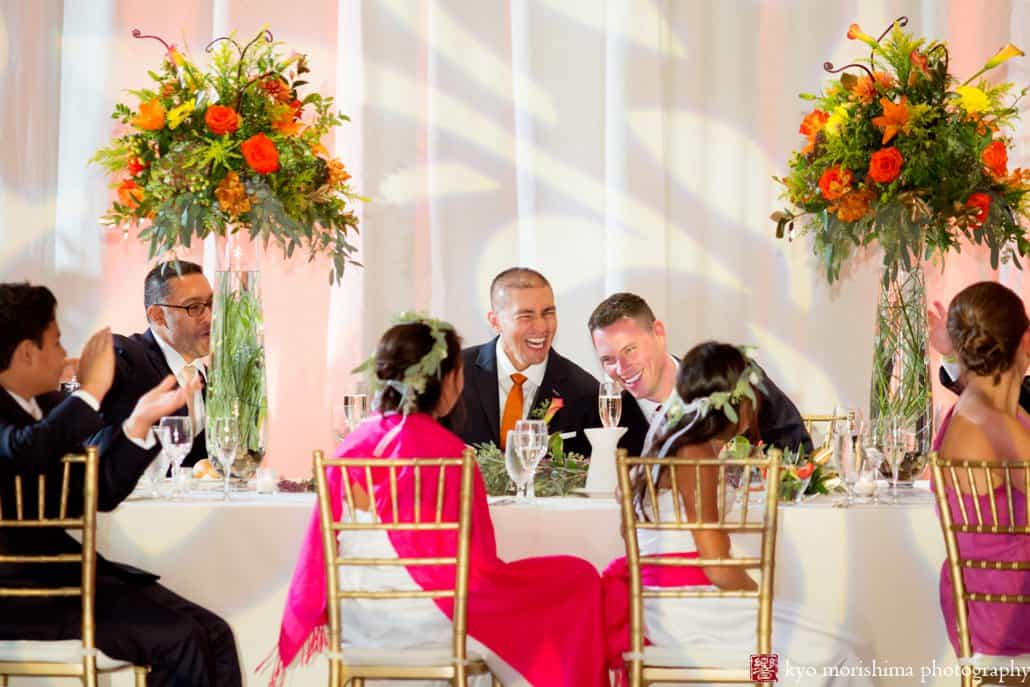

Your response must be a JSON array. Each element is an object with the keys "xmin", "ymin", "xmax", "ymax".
[{"xmin": 0, "ymin": 388, "xmax": 158, "ymax": 586}]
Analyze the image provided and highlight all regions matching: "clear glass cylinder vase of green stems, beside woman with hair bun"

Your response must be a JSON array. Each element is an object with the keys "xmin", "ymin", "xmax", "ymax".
[{"xmin": 869, "ymin": 263, "xmax": 933, "ymax": 484}]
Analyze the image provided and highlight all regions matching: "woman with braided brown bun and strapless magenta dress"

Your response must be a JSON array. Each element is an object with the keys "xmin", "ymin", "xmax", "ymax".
[{"xmin": 934, "ymin": 281, "xmax": 1030, "ymax": 656}]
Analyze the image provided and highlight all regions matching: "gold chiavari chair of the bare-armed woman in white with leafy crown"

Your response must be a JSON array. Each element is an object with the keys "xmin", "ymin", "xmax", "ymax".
[{"xmin": 618, "ymin": 449, "xmax": 782, "ymax": 687}]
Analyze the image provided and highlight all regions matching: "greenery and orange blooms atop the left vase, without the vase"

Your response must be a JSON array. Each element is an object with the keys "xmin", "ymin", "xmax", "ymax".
[{"xmin": 92, "ymin": 31, "xmax": 367, "ymax": 283}]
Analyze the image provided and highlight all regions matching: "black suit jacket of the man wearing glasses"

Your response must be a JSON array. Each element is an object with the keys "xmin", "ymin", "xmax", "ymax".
[{"xmin": 91, "ymin": 330, "xmax": 207, "ymax": 468}]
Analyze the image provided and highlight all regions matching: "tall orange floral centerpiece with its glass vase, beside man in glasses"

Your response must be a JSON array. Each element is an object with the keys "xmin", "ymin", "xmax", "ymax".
[{"xmin": 94, "ymin": 30, "xmax": 364, "ymax": 475}]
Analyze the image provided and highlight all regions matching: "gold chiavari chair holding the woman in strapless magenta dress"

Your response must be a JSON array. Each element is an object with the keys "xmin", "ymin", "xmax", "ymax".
[{"xmin": 930, "ymin": 453, "xmax": 1030, "ymax": 687}]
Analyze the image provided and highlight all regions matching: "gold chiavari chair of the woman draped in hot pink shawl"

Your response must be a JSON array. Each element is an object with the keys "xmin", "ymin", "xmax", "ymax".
[{"xmin": 314, "ymin": 450, "xmax": 501, "ymax": 687}]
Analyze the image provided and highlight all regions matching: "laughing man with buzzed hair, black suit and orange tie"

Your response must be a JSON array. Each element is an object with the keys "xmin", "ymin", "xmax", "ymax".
[{"xmin": 444, "ymin": 267, "xmax": 600, "ymax": 455}]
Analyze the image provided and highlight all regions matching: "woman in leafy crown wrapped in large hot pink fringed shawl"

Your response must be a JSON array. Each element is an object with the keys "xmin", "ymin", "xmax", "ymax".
[{"xmin": 272, "ymin": 314, "xmax": 608, "ymax": 687}]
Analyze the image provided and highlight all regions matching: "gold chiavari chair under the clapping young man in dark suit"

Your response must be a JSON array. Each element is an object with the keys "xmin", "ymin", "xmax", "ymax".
[{"xmin": 0, "ymin": 447, "xmax": 147, "ymax": 687}]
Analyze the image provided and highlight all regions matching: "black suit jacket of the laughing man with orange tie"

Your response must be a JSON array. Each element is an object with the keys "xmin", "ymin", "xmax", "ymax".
[{"xmin": 444, "ymin": 338, "xmax": 600, "ymax": 455}]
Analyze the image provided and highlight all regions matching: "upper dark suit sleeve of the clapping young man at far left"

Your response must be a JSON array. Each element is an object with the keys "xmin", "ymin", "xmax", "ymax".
[{"xmin": 0, "ymin": 397, "xmax": 102, "ymax": 473}]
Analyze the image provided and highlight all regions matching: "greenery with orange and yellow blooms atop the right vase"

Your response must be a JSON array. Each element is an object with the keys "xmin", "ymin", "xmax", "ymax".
[{"xmin": 771, "ymin": 24, "xmax": 1030, "ymax": 284}]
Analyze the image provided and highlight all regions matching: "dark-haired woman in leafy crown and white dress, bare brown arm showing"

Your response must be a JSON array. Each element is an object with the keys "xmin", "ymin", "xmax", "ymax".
[{"xmin": 604, "ymin": 341, "xmax": 873, "ymax": 687}]
